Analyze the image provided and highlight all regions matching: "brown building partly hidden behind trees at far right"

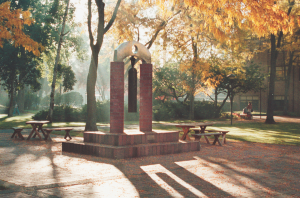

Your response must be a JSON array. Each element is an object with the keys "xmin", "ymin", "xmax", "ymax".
[{"xmin": 234, "ymin": 52, "xmax": 300, "ymax": 113}]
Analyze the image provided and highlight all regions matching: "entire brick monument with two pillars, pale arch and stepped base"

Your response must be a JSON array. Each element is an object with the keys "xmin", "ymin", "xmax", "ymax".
[{"xmin": 62, "ymin": 41, "xmax": 200, "ymax": 159}]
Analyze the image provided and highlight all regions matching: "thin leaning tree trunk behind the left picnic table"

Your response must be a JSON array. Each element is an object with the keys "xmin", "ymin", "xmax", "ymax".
[{"xmin": 48, "ymin": 0, "xmax": 70, "ymax": 123}]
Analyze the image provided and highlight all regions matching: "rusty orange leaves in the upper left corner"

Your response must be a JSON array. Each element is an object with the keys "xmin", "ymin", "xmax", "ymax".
[{"xmin": 0, "ymin": 1, "xmax": 43, "ymax": 56}]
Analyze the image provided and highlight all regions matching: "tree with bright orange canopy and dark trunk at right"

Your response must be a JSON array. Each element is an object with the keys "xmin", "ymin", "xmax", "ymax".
[{"xmin": 151, "ymin": 0, "xmax": 300, "ymax": 123}]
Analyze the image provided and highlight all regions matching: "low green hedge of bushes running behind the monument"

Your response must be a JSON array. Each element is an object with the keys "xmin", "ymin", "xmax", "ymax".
[{"xmin": 33, "ymin": 100, "xmax": 223, "ymax": 122}]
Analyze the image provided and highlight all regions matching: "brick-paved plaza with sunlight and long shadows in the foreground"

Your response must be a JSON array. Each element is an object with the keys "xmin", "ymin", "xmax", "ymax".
[{"xmin": 0, "ymin": 124, "xmax": 300, "ymax": 198}]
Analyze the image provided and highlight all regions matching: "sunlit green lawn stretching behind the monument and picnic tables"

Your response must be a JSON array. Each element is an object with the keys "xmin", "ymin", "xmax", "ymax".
[{"xmin": 0, "ymin": 113, "xmax": 300, "ymax": 146}]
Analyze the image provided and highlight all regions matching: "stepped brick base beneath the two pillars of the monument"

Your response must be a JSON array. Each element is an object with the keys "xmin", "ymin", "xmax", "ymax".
[{"xmin": 62, "ymin": 131, "xmax": 200, "ymax": 159}]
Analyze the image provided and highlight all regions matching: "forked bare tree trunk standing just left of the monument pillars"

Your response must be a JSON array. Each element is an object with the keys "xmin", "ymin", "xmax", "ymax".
[{"xmin": 85, "ymin": 0, "xmax": 121, "ymax": 131}]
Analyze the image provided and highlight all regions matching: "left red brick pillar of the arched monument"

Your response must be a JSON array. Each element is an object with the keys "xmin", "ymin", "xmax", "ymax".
[{"xmin": 110, "ymin": 62, "xmax": 124, "ymax": 133}]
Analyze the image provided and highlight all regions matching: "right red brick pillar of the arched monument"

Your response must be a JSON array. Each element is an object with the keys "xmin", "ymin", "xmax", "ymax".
[{"xmin": 140, "ymin": 64, "xmax": 152, "ymax": 132}]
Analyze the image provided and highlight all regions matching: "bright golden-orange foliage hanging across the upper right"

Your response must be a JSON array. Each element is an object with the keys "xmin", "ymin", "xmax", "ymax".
[{"xmin": 146, "ymin": 0, "xmax": 299, "ymax": 40}]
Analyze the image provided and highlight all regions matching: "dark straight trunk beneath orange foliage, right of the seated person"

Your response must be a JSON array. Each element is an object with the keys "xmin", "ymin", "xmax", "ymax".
[{"xmin": 265, "ymin": 34, "xmax": 280, "ymax": 124}]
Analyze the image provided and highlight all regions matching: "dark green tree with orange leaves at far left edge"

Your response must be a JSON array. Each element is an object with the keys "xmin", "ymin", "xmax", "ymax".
[{"xmin": 0, "ymin": 1, "xmax": 44, "ymax": 116}]
